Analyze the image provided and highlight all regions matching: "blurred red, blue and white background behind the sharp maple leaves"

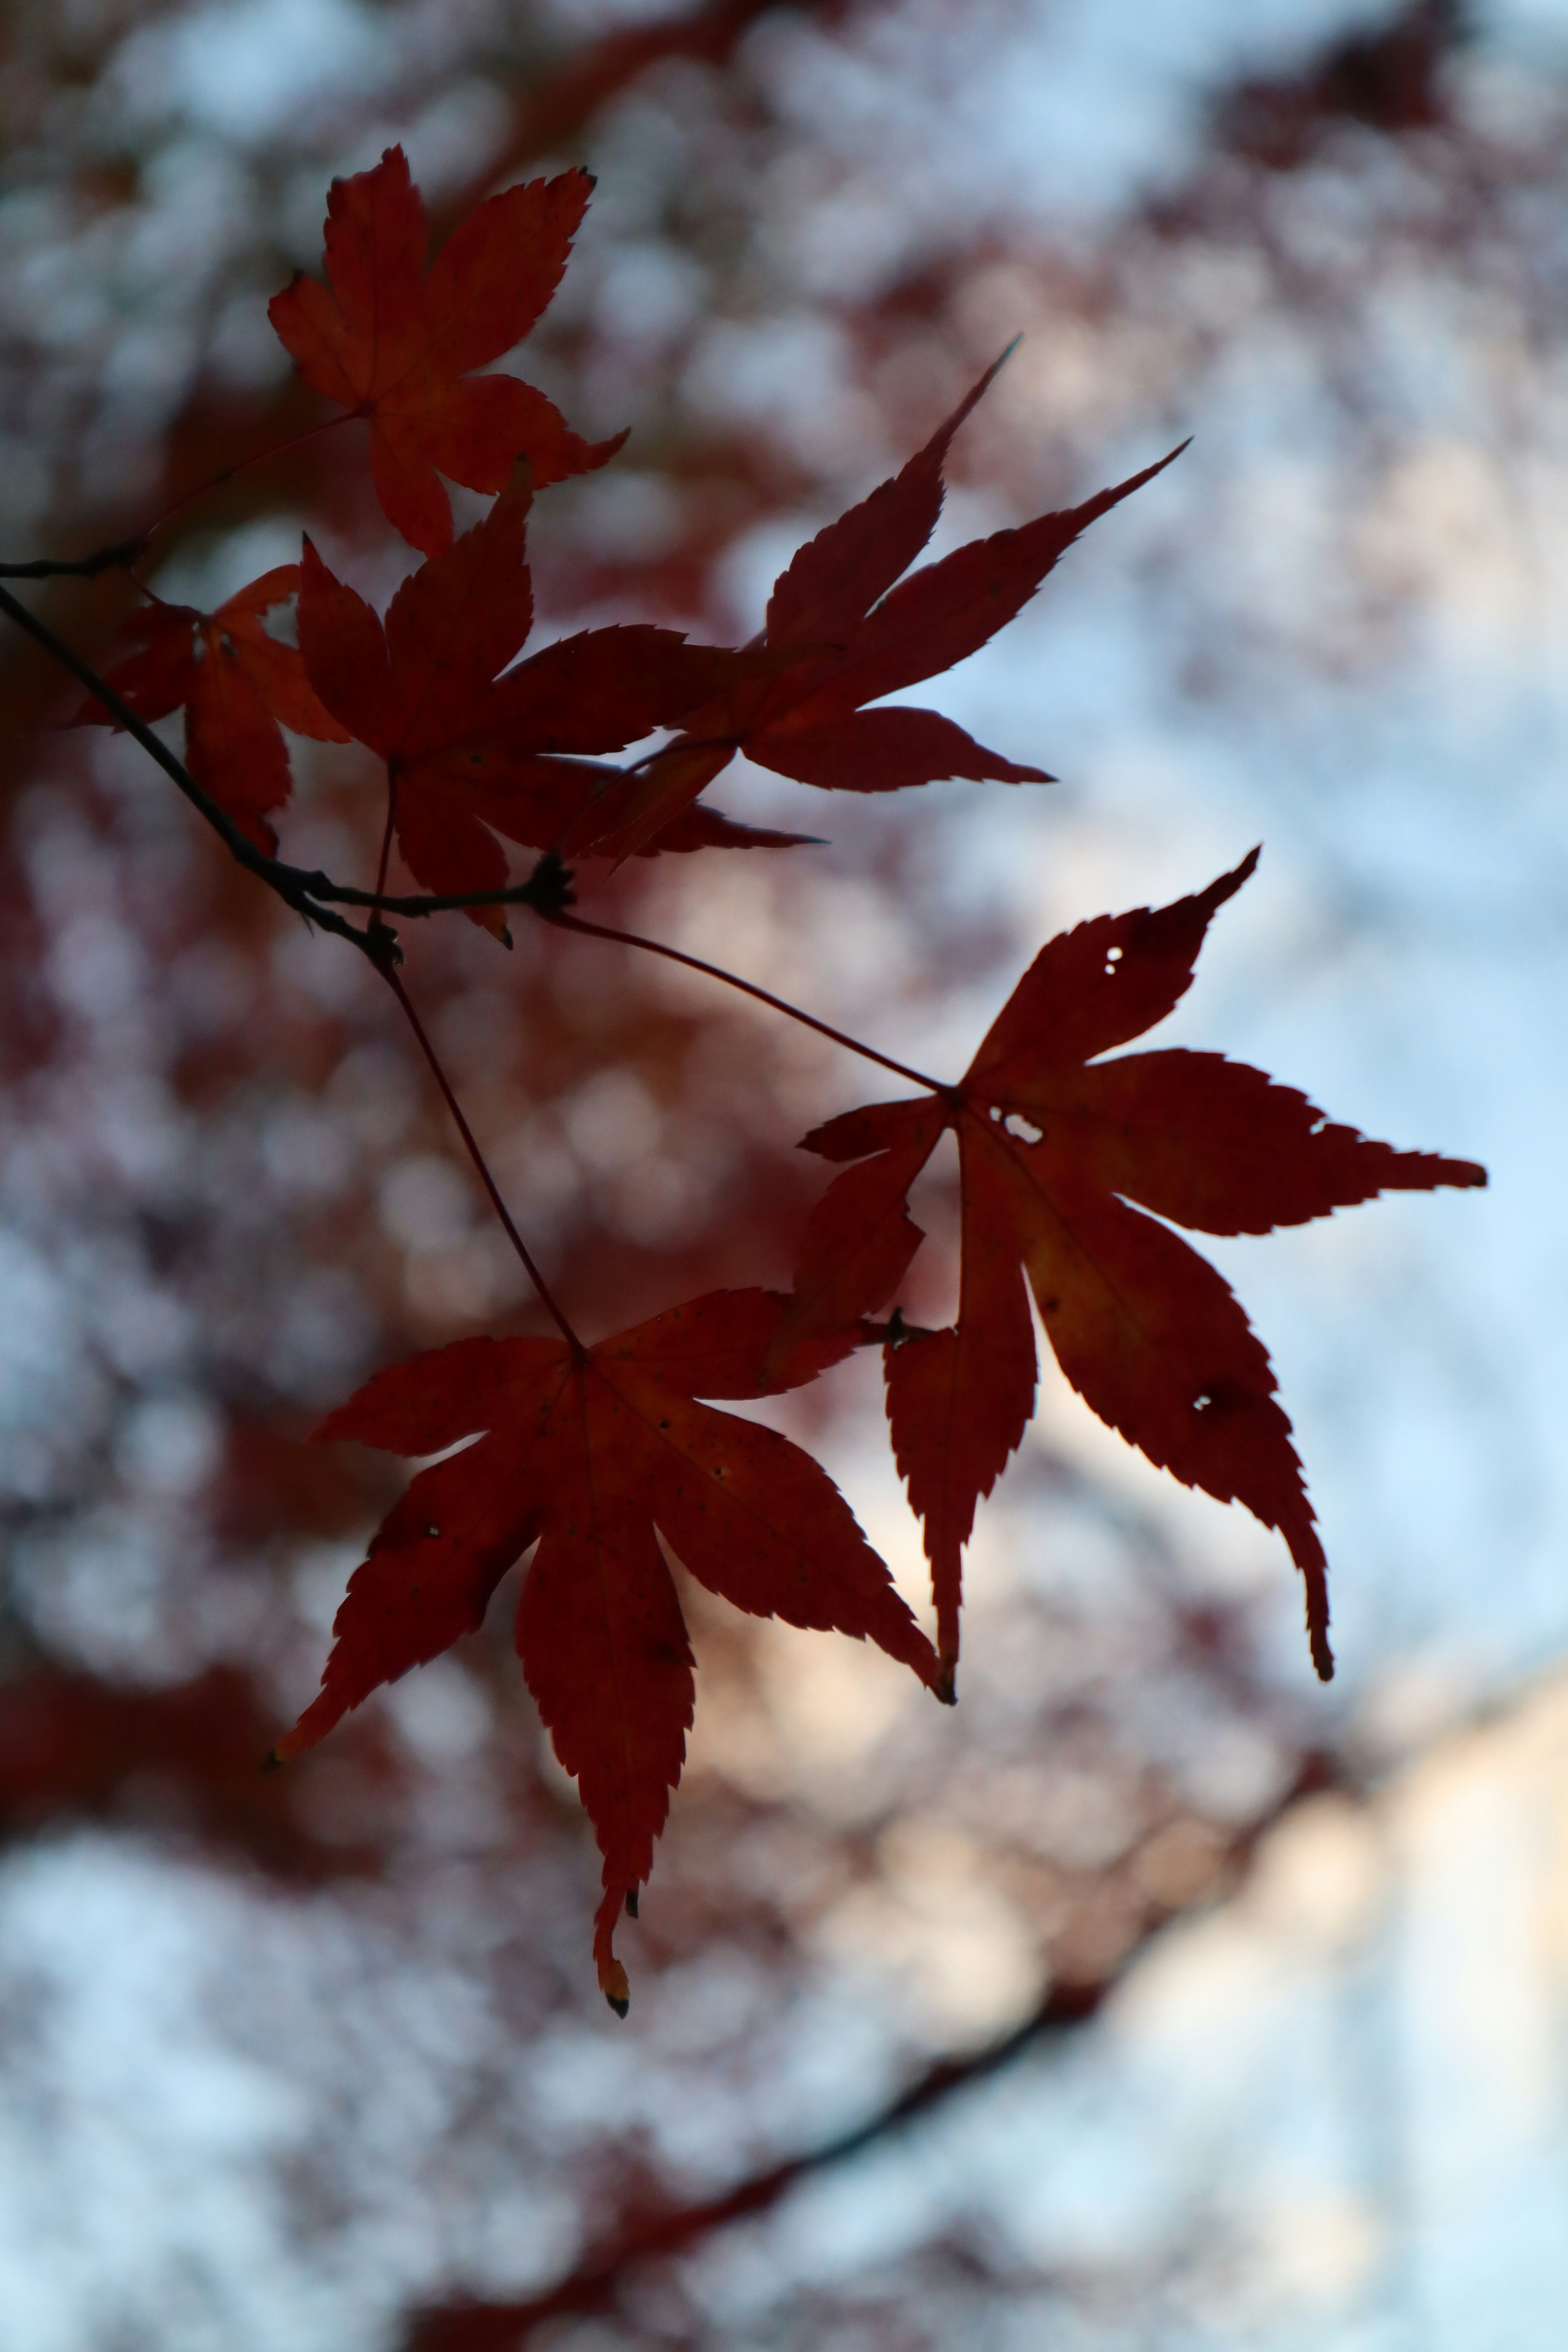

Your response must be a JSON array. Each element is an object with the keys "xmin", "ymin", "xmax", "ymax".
[{"xmin": 0, "ymin": 0, "xmax": 1568, "ymax": 2352}]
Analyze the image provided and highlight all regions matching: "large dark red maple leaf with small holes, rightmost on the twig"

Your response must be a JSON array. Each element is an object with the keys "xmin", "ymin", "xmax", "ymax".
[{"xmin": 773, "ymin": 849, "xmax": 1486, "ymax": 1682}]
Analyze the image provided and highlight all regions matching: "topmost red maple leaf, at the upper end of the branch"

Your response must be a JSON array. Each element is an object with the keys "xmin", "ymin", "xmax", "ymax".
[{"xmin": 268, "ymin": 146, "xmax": 625, "ymax": 555}]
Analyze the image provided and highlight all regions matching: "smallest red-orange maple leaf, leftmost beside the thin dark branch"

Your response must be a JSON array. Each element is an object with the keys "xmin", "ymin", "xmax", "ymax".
[{"xmin": 71, "ymin": 564, "xmax": 348, "ymax": 854}]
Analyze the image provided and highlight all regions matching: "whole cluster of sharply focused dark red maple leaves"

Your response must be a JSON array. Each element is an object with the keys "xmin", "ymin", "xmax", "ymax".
[{"xmin": 82, "ymin": 151, "xmax": 1486, "ymax": 2011}]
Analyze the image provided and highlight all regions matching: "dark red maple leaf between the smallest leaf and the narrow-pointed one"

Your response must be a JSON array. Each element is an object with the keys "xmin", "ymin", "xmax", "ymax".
[{"xmin": 298, "ymin": 468, "xmax": 799, "ymax": 938}]
